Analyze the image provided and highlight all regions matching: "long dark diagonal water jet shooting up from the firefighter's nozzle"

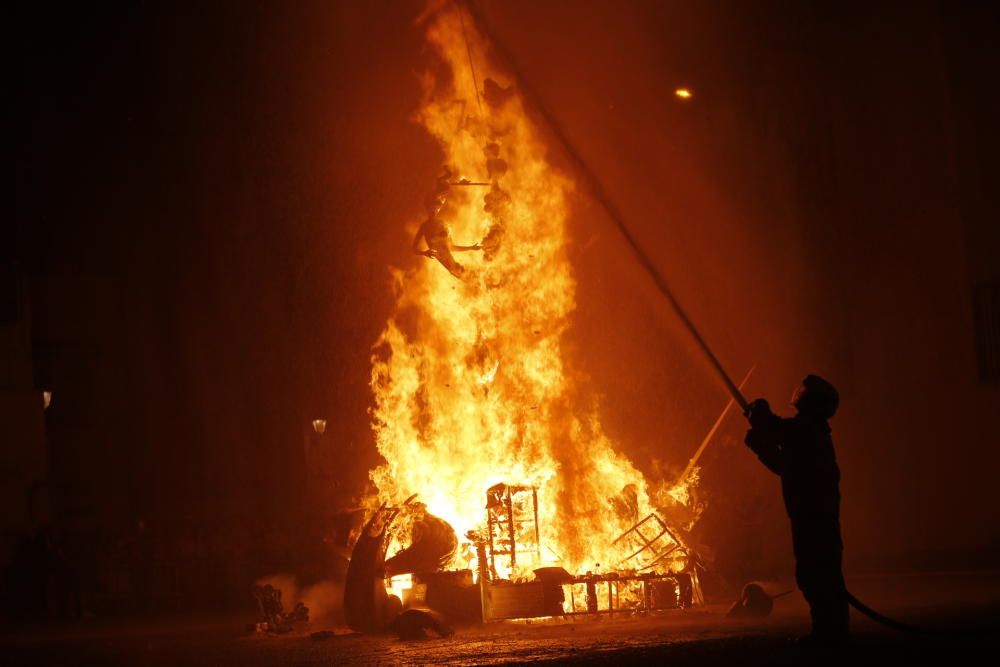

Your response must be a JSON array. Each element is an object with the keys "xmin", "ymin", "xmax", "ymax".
[{"xmin": 466, "ymin": 2, "xmax": 750, "ymax": 412}]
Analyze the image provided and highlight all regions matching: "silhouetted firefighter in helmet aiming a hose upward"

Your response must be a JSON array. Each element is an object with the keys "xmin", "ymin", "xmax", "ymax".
[{"xmin": 746, "ymin": 375, "xmax": 850, "ymax": 642}]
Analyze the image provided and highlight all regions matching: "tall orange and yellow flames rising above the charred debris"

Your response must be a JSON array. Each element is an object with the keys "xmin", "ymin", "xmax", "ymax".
[{"xmin": 371, "ymin": 5, "xmax": 692, "ymax": 577}]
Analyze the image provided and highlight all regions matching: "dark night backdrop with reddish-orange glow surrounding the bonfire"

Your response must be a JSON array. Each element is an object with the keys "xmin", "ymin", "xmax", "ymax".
[{"xmin": 4, "ymin": 0, "xmax": 1000, "ymax": 580}]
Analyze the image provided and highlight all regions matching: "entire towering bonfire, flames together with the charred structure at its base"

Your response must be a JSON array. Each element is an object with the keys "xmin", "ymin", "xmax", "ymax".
[{"xmin": 346, "ymin": 2, "xmax": 699, "ymax": 630}]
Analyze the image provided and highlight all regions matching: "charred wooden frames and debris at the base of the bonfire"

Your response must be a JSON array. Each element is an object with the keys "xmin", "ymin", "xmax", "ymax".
[{"xmin": 344, "ymin": 484, "xmax": 702, "ymax": 632}]
